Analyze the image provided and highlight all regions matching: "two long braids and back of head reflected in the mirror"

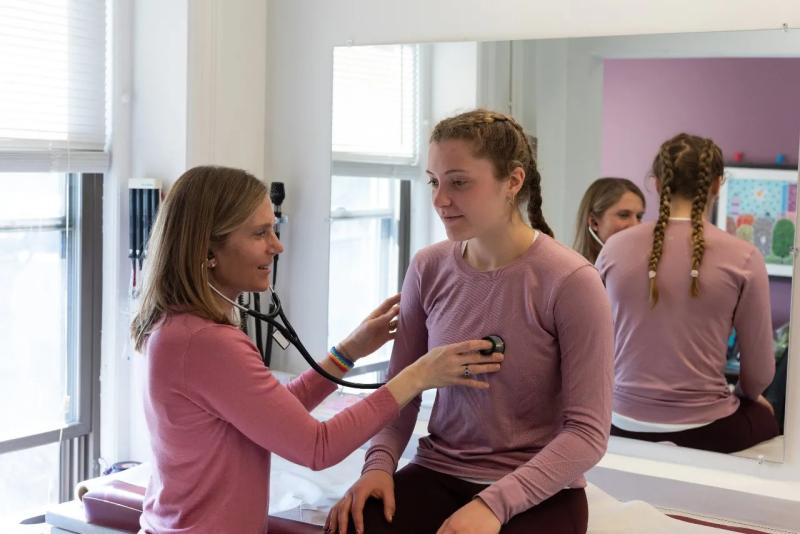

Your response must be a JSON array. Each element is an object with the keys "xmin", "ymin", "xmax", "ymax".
[{"xmin": 647, "ymin": 133, "xmax": 724, "ymax": 306}]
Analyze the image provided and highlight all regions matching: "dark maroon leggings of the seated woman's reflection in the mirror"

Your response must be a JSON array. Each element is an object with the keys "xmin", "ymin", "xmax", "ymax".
[{"xmin": 611, "ymin": 399, "xmax": 779, "ymax": 453}]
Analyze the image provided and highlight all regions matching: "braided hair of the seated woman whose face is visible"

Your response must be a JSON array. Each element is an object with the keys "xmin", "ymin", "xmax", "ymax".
[{"xmin": 430, "ymin": 109, "xmax": 553, "ymax": 237}]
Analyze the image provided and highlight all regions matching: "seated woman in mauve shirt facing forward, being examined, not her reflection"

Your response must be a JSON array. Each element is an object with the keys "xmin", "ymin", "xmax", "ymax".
[{"xmin": 327, "ymin": 110, "xmax": 612, "ymax": 534}]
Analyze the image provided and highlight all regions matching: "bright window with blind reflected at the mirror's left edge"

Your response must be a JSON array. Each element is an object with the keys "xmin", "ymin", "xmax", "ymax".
[{"xmin": 328, "ymin": 45, "xmax": 421, "ymax": 382}]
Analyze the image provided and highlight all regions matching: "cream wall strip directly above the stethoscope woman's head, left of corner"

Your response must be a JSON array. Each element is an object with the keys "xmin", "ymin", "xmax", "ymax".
[{"xmin": 187, "ymin": 0, "xmax": 270, "ymax": 173}]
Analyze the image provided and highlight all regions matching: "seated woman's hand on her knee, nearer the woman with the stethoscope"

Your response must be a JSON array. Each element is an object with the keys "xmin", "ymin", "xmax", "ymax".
[{"xmin": 325, "ymin": 470, "xmax": 395, "ymax": 534}]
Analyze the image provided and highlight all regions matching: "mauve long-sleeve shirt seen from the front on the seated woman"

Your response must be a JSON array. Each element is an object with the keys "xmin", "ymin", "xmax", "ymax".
[{"xmin": 364, "ymin": 234, "xmax": 613, "ymax": 523}]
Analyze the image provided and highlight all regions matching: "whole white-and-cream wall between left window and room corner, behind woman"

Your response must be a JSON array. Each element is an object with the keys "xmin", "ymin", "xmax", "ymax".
[{"xmin": 100, "ymin": 0, "xmax": 267, "ymax": 463}]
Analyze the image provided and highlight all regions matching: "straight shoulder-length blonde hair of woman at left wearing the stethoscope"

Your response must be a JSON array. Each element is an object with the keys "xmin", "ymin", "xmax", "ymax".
[{"xmin": 131, "ymin": 166, "xmax": 267, "ymax": 351}]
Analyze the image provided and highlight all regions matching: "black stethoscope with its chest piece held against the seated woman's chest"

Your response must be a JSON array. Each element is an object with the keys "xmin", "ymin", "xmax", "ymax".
[{"xmin": 208, "ymin": 282, "xmax": 506, "ymax": 389}]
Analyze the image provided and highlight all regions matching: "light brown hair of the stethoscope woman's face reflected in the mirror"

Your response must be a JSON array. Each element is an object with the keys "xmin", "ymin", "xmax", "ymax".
[{"xmin": 572, "ymin": 177, "xmax": 646, "ymax": 263}]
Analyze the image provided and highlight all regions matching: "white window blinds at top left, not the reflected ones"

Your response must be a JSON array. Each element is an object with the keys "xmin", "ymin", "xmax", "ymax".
[{"xmin": 0, "ymin": 0, "xmax": 108, "ymax": 172}]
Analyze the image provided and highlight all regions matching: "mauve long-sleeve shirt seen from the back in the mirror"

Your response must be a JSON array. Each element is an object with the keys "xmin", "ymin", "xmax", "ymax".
[{"xmin": 596, "ymin": 220, "xmax": 775, "ymax": 424}]
